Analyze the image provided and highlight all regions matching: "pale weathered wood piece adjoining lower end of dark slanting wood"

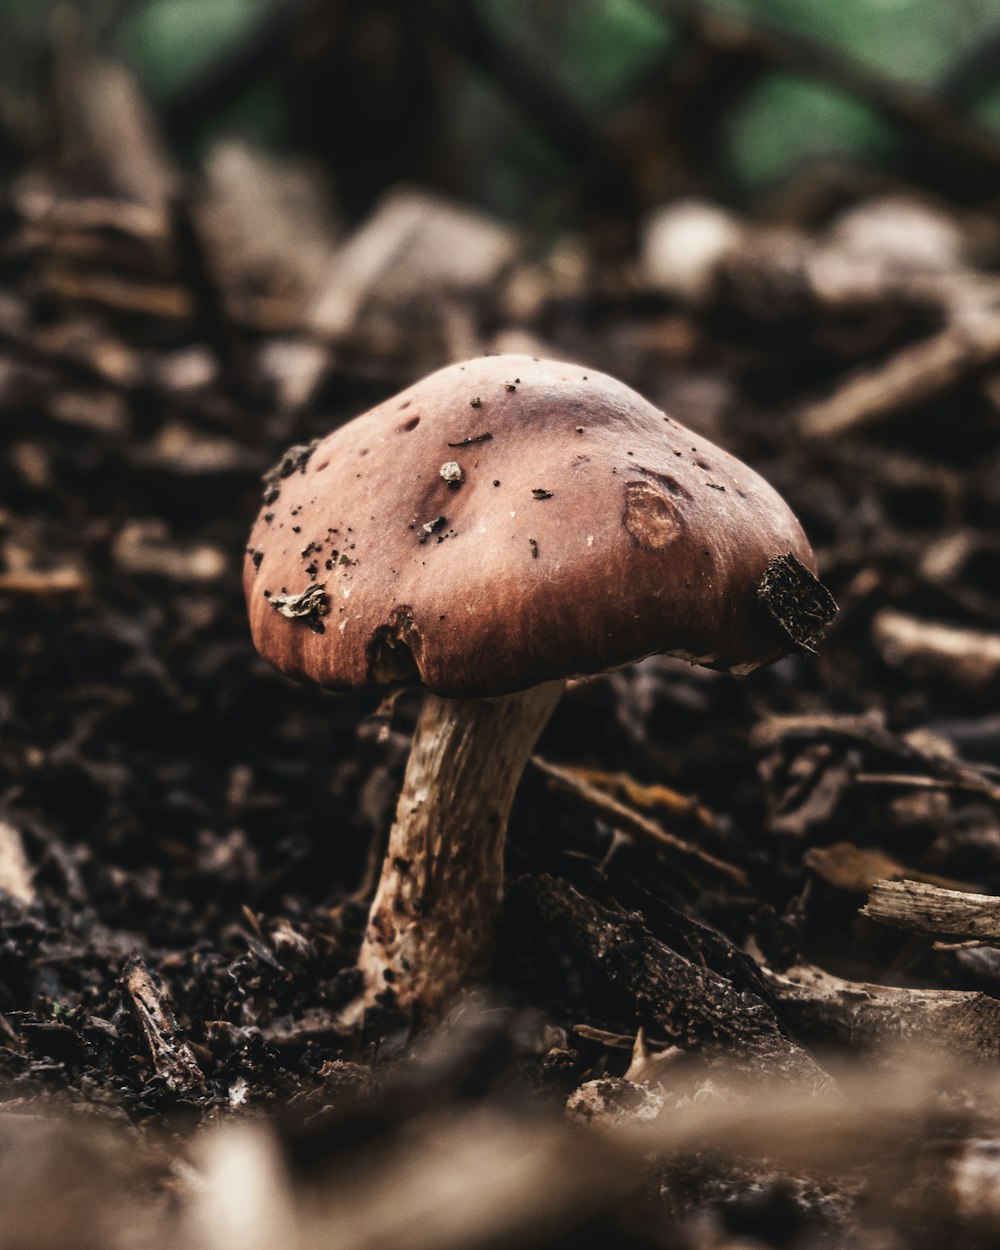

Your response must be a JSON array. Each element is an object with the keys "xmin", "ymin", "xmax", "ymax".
[{"xmin": 763, "ymin": 964, "xmax": 1000, "ymax": 1061}]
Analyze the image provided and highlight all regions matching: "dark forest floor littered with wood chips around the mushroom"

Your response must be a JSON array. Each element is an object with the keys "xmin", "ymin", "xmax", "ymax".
[{"xmin": 9, "ymin": 60, "xmax": 1000, "ymax": 1250}]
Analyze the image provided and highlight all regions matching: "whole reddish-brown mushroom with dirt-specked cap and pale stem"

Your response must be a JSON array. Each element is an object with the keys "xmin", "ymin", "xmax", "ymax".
[{"xmin": 244, "ymin": 356, "xmax": 831, "ymax": 1019}]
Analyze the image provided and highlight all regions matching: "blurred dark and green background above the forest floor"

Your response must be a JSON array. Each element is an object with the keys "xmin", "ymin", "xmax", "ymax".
[{"xmin": 0, "ymin": 0, "xmax": 1000, "ymax": 215}]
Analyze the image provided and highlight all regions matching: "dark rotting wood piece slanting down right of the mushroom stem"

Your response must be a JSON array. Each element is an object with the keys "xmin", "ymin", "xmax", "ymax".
[{"xmin": 505, "ymin": 876, "xmax": 829, "ymax": 1089}]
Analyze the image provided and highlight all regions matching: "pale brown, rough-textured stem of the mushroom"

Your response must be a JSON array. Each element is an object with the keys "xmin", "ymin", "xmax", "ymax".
[{"xmin": 359, "ymin": 681, "xmax": 565, "ymax": 1020}]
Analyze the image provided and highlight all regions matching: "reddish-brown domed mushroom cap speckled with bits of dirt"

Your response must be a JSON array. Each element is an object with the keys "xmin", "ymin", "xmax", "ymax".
[{"xmin": 244, "ymin": 356, "xmax": 814, "ymax": 696}]
